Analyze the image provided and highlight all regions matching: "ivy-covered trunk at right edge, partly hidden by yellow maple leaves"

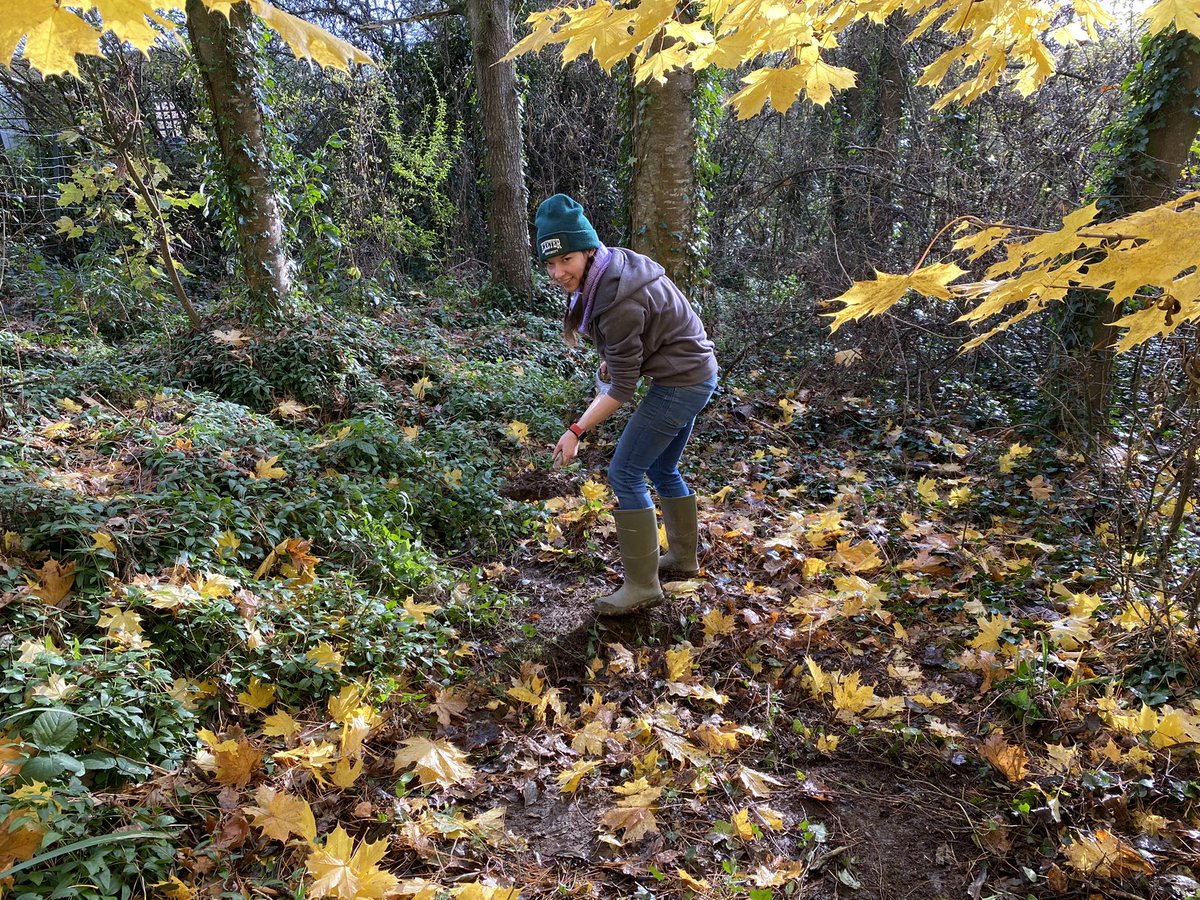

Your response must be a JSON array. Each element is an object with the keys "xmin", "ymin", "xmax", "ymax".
[{"xmin": 1061, "ymin": 32, "xmax": 1200, "ymax": 436}]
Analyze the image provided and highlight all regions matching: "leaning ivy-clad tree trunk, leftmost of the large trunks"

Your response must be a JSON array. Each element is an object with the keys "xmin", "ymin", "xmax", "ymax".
[{"xmin": 187, "ymin": 0, "xmax": 292, "ymax": 317}]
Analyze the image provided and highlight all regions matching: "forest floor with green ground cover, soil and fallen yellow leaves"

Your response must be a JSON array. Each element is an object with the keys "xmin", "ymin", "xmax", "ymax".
[{"xmin": 0, "ymin": 303, "xmax": 1200, "ymax": 900}]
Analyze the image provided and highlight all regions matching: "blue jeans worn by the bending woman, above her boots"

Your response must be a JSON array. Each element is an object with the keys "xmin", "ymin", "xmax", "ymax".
[{"xmin": 608, "ymin": 376, "xmax": 716, "ymax": 509}]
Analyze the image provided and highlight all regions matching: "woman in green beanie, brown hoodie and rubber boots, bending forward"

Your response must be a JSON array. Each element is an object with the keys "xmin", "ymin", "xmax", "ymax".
[{"xmin": 534, "ymin": 193, "xmax": 716, "ymax": 616}]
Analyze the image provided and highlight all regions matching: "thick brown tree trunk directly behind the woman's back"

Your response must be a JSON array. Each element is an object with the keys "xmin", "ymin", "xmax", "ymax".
[{"xmin": 629, "ymin": 35, "xmax": 697, "ymax": 292}]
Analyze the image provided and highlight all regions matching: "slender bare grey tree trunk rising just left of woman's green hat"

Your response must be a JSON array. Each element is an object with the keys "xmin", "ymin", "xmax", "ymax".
[{"xmin": 467, "ymin": 0, "xmax": 533, "ymax": 296}]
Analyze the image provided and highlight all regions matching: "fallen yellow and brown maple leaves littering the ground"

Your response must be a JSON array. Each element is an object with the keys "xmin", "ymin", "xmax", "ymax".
[{"xmin": 0, "ymin": 331, "xmax": 1200, "ymax": 900}]
